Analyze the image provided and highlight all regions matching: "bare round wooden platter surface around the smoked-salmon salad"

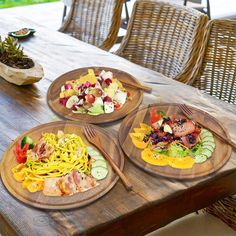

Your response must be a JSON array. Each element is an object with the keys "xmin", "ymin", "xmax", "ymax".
[{"xmin": 119, "ymin": 103, "xmax": 232, "ymax": 179}]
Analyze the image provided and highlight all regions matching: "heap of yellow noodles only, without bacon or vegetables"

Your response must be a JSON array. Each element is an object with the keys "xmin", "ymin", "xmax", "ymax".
[{"xmin": 13, "ymin": 133, "xmax": 90, "ymax": 181}]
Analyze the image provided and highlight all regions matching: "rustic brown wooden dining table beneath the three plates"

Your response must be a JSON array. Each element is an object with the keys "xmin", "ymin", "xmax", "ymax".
[{"xmin": 0, "ymin": 15, "xmax": 236, "ymax": 236}]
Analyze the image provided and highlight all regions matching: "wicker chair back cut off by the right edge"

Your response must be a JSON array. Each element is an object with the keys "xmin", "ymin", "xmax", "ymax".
[{"xmin": 193, "ymin": 19, "xmax": 236, "ymax": 104}]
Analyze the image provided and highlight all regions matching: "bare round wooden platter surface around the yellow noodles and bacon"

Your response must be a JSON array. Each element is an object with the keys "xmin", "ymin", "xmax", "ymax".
[{"xmin": 1, "ymin": 121, "xmax": 124, "ymax": 210}]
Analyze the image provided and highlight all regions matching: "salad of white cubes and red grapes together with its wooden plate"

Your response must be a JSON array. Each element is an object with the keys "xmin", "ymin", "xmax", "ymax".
[{"xmin": 47, "ymin": 67, "xmax": 143, "ymax": 123}]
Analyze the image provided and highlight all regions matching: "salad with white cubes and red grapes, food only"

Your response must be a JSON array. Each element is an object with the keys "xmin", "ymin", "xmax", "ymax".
[{"xmin": 59, "ymin": 69, "xmax": 132, "ymax": 116}]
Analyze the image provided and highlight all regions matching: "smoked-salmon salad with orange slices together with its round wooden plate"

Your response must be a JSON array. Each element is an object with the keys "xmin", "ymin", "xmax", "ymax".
[{"xmin": 119, "ymin": 103, "xmax": 232, "ymax": 179}]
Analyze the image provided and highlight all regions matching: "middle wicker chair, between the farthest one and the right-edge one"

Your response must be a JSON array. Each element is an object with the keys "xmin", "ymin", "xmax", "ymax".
[{"xmin": 116, "ymin": 0, "xmax": 208, "ymax": 83}]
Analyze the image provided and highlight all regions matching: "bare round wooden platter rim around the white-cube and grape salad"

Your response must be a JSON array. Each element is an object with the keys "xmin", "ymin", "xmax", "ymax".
[{"xmin": 47, "ymin": 67, "xmax": 143, "ymax": 124}]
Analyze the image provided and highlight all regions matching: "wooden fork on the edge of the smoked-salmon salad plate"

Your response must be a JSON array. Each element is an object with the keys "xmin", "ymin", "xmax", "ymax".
[{"xmin": 179, "ymin": 104, "xmax": 236, "ymax": 148}]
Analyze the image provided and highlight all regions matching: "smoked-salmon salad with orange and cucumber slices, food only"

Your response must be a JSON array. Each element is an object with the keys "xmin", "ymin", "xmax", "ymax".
[{"xmin": 129, "ymin": 108, "xmax": 215, "ymax": 169}]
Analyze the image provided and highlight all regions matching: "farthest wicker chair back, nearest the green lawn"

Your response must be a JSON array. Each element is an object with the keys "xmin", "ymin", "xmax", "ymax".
[{"xmin": 59, "ymin": 0, "xmax": 123, "ymax": 50}]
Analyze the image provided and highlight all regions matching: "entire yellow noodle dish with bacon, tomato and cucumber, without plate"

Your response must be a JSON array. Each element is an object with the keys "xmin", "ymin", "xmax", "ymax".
[{"xmin": 12, "ymin": 130, "xmax": 108, "ymax": 196}]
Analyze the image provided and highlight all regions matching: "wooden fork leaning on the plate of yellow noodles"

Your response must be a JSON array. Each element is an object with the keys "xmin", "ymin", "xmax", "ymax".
[{"xmin": 83, "ymin": 125, "xmax": 133, "ymax": 191}]
